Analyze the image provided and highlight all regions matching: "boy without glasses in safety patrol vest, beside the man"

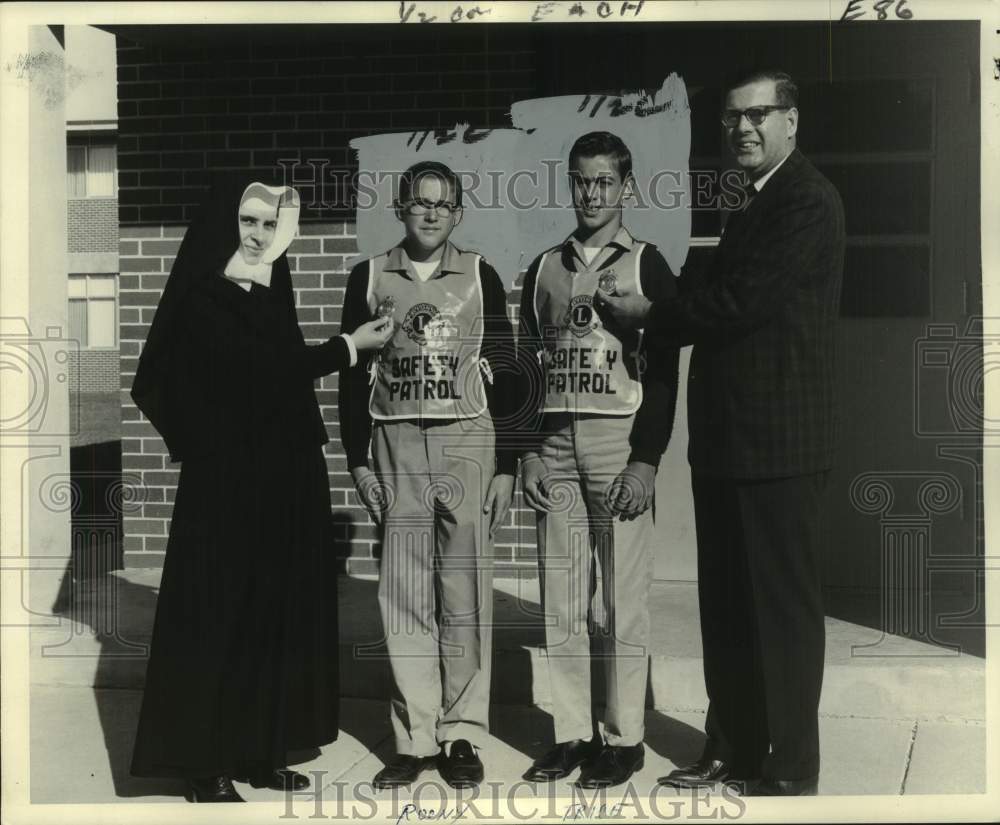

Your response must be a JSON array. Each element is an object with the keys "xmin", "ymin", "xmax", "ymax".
[{"xmin": 521, "ymin": 132, "xmax": 678, "ymax": 788}]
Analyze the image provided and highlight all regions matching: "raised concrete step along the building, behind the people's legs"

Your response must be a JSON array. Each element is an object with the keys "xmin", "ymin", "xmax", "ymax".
[{"xmin": 31, "ymin": 570, "xmax": 986, "ymax": 720}]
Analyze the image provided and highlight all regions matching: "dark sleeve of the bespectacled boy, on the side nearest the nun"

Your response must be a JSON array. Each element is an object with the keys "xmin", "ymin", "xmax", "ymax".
[{"xmin": 338, "ymin": 261, "xmax": 372, "ymax": 469}]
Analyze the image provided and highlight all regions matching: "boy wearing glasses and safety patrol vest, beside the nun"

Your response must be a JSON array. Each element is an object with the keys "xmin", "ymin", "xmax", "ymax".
[{"xmin": 339, "ymin": 161, "xmax": 523, "ymax": 788}]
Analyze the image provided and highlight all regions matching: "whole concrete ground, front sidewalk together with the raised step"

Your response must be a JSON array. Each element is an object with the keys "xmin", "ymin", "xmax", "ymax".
[{"xmin": 31, "ymin": 570, "xmax": 986, "ymax": 803}]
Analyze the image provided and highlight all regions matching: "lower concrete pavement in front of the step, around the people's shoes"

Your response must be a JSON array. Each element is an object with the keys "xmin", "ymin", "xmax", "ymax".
[{"xmin": 26, "ymin": 686, "xmax": 986, "ymax": 804}]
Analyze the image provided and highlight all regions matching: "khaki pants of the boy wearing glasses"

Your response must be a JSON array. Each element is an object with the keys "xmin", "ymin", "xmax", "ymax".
[{"xmin": 372, "ymin": 416, "xmax": 495, "ymax": 756}]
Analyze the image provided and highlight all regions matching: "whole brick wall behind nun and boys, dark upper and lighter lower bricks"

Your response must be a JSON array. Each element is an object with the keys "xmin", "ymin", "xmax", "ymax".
[{"xmin": 118, "ymin": 27, "xmax": 537, "ymax": 573}]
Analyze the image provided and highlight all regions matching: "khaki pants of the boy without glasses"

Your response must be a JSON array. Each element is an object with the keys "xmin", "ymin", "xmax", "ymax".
[{"xmin": 538, "ymin": 415, "xmax": 653, "ymax": 745}]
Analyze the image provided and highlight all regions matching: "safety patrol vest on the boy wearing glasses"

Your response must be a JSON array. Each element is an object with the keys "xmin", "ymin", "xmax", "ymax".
[{"xmin": 368, "ymin": 244, "xmax": 487, "ymax": 421}]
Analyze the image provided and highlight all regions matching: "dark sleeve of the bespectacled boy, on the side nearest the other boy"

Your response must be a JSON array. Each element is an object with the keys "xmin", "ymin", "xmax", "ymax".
[{"xmin": 479, "ymin": 261, "xmax": 521, "ymax": 475}]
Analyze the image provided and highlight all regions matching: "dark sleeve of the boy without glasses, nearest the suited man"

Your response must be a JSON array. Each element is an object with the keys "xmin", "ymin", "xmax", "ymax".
[{"xmin": 628, "ymin": 244, "xmax": 680, "ymax": 467}]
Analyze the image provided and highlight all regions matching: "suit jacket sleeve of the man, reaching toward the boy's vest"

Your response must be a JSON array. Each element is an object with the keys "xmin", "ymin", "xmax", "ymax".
[{"xmin": 646, "ymin": 181, "xmax": 835, "ymax": 346}]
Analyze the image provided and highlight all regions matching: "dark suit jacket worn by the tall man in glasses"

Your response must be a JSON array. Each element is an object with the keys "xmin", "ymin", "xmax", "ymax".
[{"xmin": 646, "ymin": 150, "xmax": 844, "ymax": 479}]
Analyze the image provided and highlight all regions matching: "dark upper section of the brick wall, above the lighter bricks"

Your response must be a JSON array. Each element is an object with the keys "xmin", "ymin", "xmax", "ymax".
[{"xmin": 118, "ymin": 26, "xmax": 535, "ymax": 225}]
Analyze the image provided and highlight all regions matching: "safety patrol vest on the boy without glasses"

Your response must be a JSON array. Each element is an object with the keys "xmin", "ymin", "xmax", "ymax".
[{"xmin": 534, "ymin": 241, "xmax": 646, "ymax": 415}]
